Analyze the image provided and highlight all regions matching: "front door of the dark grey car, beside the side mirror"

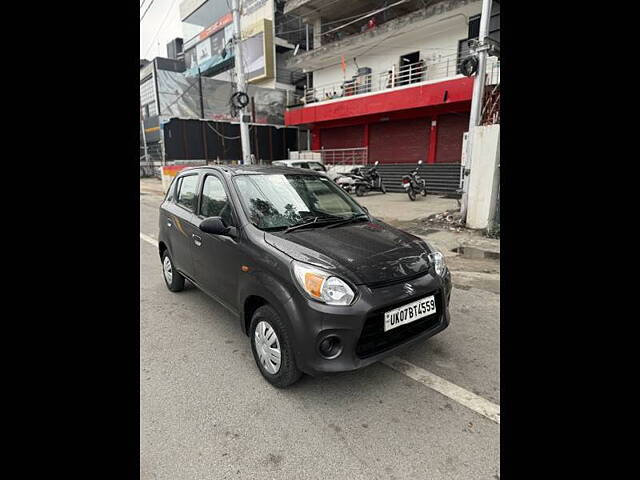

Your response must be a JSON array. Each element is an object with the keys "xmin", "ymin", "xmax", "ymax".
[{"xmin": 193, "ymin": 173, "xmax": 244, "ymax": 311}]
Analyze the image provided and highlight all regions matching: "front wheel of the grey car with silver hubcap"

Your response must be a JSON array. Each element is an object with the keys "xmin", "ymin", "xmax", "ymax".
[{"xmin": 249, "ymin": 305, "xmax": 302, "ymax": 388}]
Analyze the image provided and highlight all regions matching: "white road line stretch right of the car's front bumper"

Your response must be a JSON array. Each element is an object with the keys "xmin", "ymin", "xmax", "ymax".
[{"xmin": 382, "ymin": 357, "xmax": 500, "ymax": 425}]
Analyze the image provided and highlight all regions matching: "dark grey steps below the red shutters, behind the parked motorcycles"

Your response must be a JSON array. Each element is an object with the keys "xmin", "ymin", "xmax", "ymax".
[{"xmin": 376, "ymin": 163, "xmax": 460, "ymax": 193}]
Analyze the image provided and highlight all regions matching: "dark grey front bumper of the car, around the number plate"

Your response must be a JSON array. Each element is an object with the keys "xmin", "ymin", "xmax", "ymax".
[{"xmin": 284, "ymin": 271, "xmax": 451, "ymax": 375}]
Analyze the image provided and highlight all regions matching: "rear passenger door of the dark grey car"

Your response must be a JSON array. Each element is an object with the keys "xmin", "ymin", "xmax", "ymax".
[{"xmin": 163, "ymin": 172, "xmax": 199, "ymax": 278}]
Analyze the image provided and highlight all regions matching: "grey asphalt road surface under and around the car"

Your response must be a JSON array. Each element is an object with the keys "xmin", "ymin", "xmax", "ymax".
[{"xmin": 140, "ymin": 195, "xmax": 500, "ymax": 480}]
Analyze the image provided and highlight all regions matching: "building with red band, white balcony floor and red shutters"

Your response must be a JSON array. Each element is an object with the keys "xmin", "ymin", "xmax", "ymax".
[{"xmin": 284, "ymin": 0, "xmax": 500, "ymax": 164}]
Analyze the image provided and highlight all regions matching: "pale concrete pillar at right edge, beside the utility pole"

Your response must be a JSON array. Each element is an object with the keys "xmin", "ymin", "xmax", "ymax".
[{"xmin": 467, "ymin": 124, "xmax": 500, "ymax": 229}]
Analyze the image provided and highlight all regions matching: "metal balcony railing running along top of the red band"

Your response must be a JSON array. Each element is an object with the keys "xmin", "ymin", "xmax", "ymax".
[{"xmin": 287, "ymin": 54, "xmax": 500, "ymax": 107}]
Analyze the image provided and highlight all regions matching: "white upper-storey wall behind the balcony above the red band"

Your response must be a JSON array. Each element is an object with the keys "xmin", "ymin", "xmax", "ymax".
[{"xmin": 313, "ymin": 2, "xmax": 481, "ymax": 89}]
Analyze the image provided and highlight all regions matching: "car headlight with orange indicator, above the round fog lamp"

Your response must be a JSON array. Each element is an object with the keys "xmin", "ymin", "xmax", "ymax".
[{"xmin": 293, "ymin": 260, "xmax": 356, "ymax": 305}]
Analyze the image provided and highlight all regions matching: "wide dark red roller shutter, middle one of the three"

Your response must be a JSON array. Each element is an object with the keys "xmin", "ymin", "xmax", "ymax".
[{"xmin": 369, "ymin": 118, "xmax": 431, "ymax": 163}]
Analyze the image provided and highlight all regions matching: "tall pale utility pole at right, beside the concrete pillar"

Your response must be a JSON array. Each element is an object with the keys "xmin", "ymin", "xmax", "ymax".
[{"xmin": 460, "ymin": 0, "xmax": 491, "ymax": 221}]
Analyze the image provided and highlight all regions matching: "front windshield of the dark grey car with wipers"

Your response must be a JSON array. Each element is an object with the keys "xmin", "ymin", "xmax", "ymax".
[{"xmin": 234, "ymin": 174, "xmax": 366, "ymax": 230}]
